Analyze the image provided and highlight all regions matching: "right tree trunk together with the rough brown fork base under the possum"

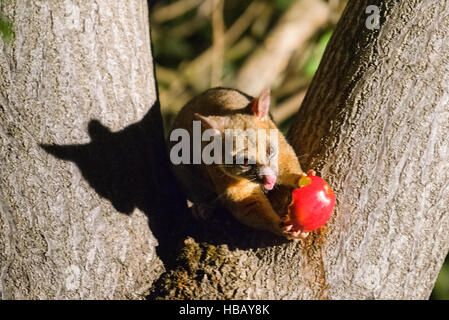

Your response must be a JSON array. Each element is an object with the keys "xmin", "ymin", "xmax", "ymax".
[{"xmin": 153, "ymin": 0, "xmax": 449, "ymax": 299}]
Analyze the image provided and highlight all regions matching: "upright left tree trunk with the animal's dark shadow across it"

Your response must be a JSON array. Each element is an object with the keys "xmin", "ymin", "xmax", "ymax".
[{"xmin": 0, "ymin": 0, "xmax": 174, "ymax": 299}]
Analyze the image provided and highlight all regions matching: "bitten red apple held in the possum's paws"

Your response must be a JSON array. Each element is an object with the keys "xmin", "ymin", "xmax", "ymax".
[{"xmin": 286, "ymin": 170, "xmax": 335, "ymax": 233}]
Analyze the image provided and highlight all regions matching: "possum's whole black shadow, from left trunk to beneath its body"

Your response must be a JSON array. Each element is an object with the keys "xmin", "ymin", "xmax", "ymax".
[{"xmin": 40, "ymin": 104, "xmax": 283, "ymax": 266}]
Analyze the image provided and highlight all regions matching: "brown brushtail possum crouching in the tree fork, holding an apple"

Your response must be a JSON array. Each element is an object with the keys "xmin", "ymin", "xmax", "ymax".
[{"xmin": 168, "ymin": 88, "xmax": 305, "ymax": 239}]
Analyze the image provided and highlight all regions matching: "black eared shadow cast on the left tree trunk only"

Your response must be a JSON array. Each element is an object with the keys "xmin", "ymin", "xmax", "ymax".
[{"xmin": 40, "ymin": 104, "xmax": 188, "ymax": 263}]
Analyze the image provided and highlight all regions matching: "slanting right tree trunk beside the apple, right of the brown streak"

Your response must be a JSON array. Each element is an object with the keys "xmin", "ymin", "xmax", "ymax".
[{"xmin": 290, "ymin": 0, "xmax": 449, "ymax": 299}]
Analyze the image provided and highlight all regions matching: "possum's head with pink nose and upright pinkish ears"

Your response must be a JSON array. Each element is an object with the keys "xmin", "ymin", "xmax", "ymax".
[{"xmin": 195, "ymin": 89, "xmax": 279, "ymax": 190}]
